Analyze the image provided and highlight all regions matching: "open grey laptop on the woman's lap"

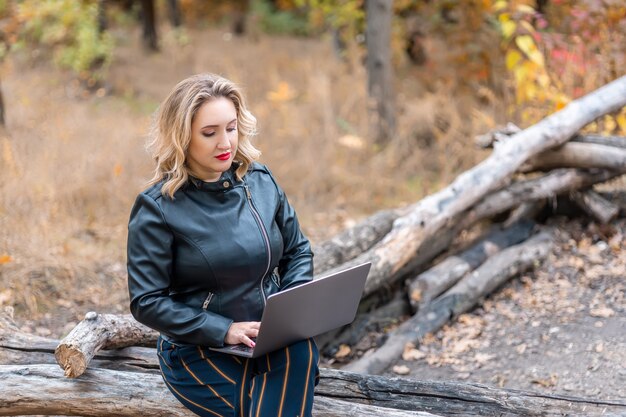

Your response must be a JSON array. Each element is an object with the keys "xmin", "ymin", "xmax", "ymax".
[{"xmin": 211, "ymin": 262, "xmax": 371, "ymax": 358}]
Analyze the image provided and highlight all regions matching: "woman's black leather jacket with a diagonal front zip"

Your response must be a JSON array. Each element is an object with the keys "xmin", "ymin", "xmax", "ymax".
[{"xmin": 128, "ymin": 163, "xmax": 313, "ymax": 346}]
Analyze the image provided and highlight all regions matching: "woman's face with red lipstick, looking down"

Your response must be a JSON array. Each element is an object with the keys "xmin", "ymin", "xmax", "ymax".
[{"xmin": 186, "ymin": 97, "xmax": 239, "ymax": 181}]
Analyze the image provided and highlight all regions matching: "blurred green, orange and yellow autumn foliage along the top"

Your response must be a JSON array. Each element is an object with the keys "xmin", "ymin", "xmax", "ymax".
[{"xmin": 0, "ymin": 0, "xmax": 626, "ymax": 137}]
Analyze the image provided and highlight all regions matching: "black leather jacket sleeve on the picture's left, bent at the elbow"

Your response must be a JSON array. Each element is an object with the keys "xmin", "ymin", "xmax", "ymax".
[{"xmin": 127, "ymin": 194, "xmax": 232, "ymax": 347}]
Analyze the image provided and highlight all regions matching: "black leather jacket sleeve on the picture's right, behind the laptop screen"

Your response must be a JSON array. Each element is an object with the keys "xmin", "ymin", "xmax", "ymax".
[{"xmin": 276, "ymin": 180, "xmax": 313, "ymax": 290}]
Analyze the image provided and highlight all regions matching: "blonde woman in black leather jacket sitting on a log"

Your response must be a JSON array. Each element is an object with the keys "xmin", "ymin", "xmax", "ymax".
[{"xmin": 128, "ymin": 74, "xmax": 319, "ymax": 417}]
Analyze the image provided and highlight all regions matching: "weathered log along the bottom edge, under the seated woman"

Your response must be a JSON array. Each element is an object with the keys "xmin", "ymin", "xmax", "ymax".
[{"xmin": 0, "ymin": 365, "xmax": 626, "ymax": 417}]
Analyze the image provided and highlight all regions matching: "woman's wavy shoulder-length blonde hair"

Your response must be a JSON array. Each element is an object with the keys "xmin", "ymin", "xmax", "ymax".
[{"xmin": 148, "ymin": 73, "xmax": 261, "ymax": 198}]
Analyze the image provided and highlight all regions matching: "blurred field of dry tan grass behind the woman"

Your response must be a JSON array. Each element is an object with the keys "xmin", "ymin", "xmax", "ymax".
[{"xmin": 0, "ymin": 25, "xmax": 532, "ymax": 332}]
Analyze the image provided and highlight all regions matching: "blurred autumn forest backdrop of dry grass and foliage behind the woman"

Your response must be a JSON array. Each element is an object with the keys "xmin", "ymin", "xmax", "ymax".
[{"xmin": 0, "ymin": 0, "xmax": 626, "ymax": 394}]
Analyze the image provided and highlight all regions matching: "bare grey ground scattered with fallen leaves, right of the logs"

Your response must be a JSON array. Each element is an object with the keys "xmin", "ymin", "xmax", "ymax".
[{"xmin": 372, "ymin": 218, "xmax": 626, "ymax": 399}]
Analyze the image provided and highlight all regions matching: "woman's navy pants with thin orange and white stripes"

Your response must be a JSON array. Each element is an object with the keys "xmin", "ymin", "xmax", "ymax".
[{"xmin": 157, "ymin": 337, "xmax": 319, "ymax": 417}]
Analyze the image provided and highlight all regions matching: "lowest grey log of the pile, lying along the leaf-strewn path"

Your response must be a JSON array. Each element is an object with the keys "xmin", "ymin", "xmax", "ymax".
[{"xmin": 343, "ymin": 232, "xmax": 552, "ymax": 374}]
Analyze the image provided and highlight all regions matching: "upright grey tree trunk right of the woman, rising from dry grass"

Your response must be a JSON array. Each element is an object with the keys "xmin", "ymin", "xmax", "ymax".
[{"xmin": 365, "ymin": 0, "xmax": 396, "ymax": 145}]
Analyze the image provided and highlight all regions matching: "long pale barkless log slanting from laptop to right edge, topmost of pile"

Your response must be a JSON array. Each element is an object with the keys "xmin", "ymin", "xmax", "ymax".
[{"xmin": 322, "ymin": 76, "xmax": 626, "ymax": 295}]
